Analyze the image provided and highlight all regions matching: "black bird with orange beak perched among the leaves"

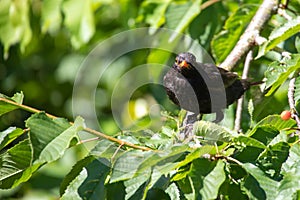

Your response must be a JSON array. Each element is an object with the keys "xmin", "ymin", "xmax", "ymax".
[{"xmin": 163, "ymin": 52, "xmax": 251, "ymax": 122}]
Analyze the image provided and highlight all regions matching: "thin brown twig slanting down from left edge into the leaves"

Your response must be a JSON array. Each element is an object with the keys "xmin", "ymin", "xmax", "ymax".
[{"xmin": 0, "ymin": 97, "xmax": 153, "ymax": 151}]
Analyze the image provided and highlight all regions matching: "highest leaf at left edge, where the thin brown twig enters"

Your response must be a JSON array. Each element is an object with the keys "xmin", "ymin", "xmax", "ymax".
[{"xmin": 0, "ymin": 92, "xmax": 24, "ymax": 116}]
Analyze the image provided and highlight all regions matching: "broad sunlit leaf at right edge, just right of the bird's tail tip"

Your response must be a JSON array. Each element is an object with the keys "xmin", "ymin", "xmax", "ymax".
[{"xmin": 265, "ymin": 54, "xmax": 300, "ymax": 96}]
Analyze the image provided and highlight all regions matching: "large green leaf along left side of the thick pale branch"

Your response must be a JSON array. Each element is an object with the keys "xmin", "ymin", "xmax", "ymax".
[{"xmin": 211, "ymin": 4, "xmax": 258, "ymax": 63}]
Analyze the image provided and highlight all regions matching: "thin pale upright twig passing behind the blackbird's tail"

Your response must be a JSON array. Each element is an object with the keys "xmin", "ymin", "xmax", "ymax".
[{"xmin": 234, "ymin": 50, "xmax": 253, "ymax": 131}]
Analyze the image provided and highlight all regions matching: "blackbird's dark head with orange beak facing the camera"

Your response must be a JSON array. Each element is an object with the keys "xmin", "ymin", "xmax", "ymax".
[{"xmin": 173, "ymin": 52, "xmax": 196, "ymax": 73}]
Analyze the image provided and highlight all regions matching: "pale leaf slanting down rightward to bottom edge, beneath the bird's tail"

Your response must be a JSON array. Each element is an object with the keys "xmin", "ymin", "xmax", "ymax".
[{"xmin": 242, "ymin": 163, "xmax": 279, "ymax": 199}]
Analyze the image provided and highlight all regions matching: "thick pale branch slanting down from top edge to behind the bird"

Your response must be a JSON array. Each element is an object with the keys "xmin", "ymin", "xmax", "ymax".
[{"xmin": 220, "ymin": 0, "xmax": 279, "ymax": 71}]
